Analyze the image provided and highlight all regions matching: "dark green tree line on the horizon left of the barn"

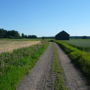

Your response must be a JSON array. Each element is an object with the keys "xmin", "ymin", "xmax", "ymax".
[{"xmin": 0, "ymin": 28, "xmax": 37, "ymax": 39}]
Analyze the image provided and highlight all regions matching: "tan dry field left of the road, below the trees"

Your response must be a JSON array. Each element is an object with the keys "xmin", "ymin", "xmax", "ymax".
[{"xmin": 0, "ymin": 40, "xmax": 40, "ymax": 53}]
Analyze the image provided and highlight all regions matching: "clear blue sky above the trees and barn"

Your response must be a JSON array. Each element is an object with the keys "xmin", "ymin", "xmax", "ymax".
[{"xmin": 0, "ymin": 0, "xmax": 90, "ymax": 36}]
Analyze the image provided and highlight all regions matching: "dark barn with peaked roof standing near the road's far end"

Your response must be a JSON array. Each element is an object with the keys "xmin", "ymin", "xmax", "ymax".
[{"xmin": 55, "ymin": 31, "xmax": 70, "ymax": 40}]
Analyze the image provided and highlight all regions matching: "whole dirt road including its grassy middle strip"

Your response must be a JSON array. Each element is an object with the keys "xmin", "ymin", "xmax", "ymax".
[{"xmin": 16, "ymin": 43, "xmax": 89, "ymax": 90}]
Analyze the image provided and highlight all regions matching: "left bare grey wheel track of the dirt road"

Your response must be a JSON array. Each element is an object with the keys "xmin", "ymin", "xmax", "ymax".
[{"xmin": 17, "ymin": 45, "xmax": 53, "ymax": 90}]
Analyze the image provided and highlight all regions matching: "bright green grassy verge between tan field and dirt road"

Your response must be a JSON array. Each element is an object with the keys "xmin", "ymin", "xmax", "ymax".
[{"xmin": 0, "ymin": 43, "xmax": 48, "ymax": 90}]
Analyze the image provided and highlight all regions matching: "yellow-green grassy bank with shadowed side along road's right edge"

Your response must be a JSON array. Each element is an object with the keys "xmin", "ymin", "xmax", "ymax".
[{"xmin": 56, "ymin": 41, "xmax": 90, "ymax": 82}]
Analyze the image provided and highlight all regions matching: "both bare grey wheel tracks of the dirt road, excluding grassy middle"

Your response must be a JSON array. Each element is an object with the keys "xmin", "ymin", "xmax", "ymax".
[{"xmin": 16, "ymin": 43, "xmax": 90, "ymax": 90}]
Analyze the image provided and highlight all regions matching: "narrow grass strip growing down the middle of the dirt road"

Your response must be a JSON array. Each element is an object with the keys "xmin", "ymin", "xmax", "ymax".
[{"xmin": 52, "ymin": 44, "xmax": 68, "ymax": 90}]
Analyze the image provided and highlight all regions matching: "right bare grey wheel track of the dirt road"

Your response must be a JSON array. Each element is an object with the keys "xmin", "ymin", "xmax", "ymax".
[{"xmin": 55, "ymin": 44, "xmax": 90, "ymax": 90}]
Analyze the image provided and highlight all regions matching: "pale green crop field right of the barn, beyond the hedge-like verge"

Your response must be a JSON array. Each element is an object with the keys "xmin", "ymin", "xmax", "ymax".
[{"xmin": 65, "ymin": 39, "xmax": 90, "ymax": 51}]
